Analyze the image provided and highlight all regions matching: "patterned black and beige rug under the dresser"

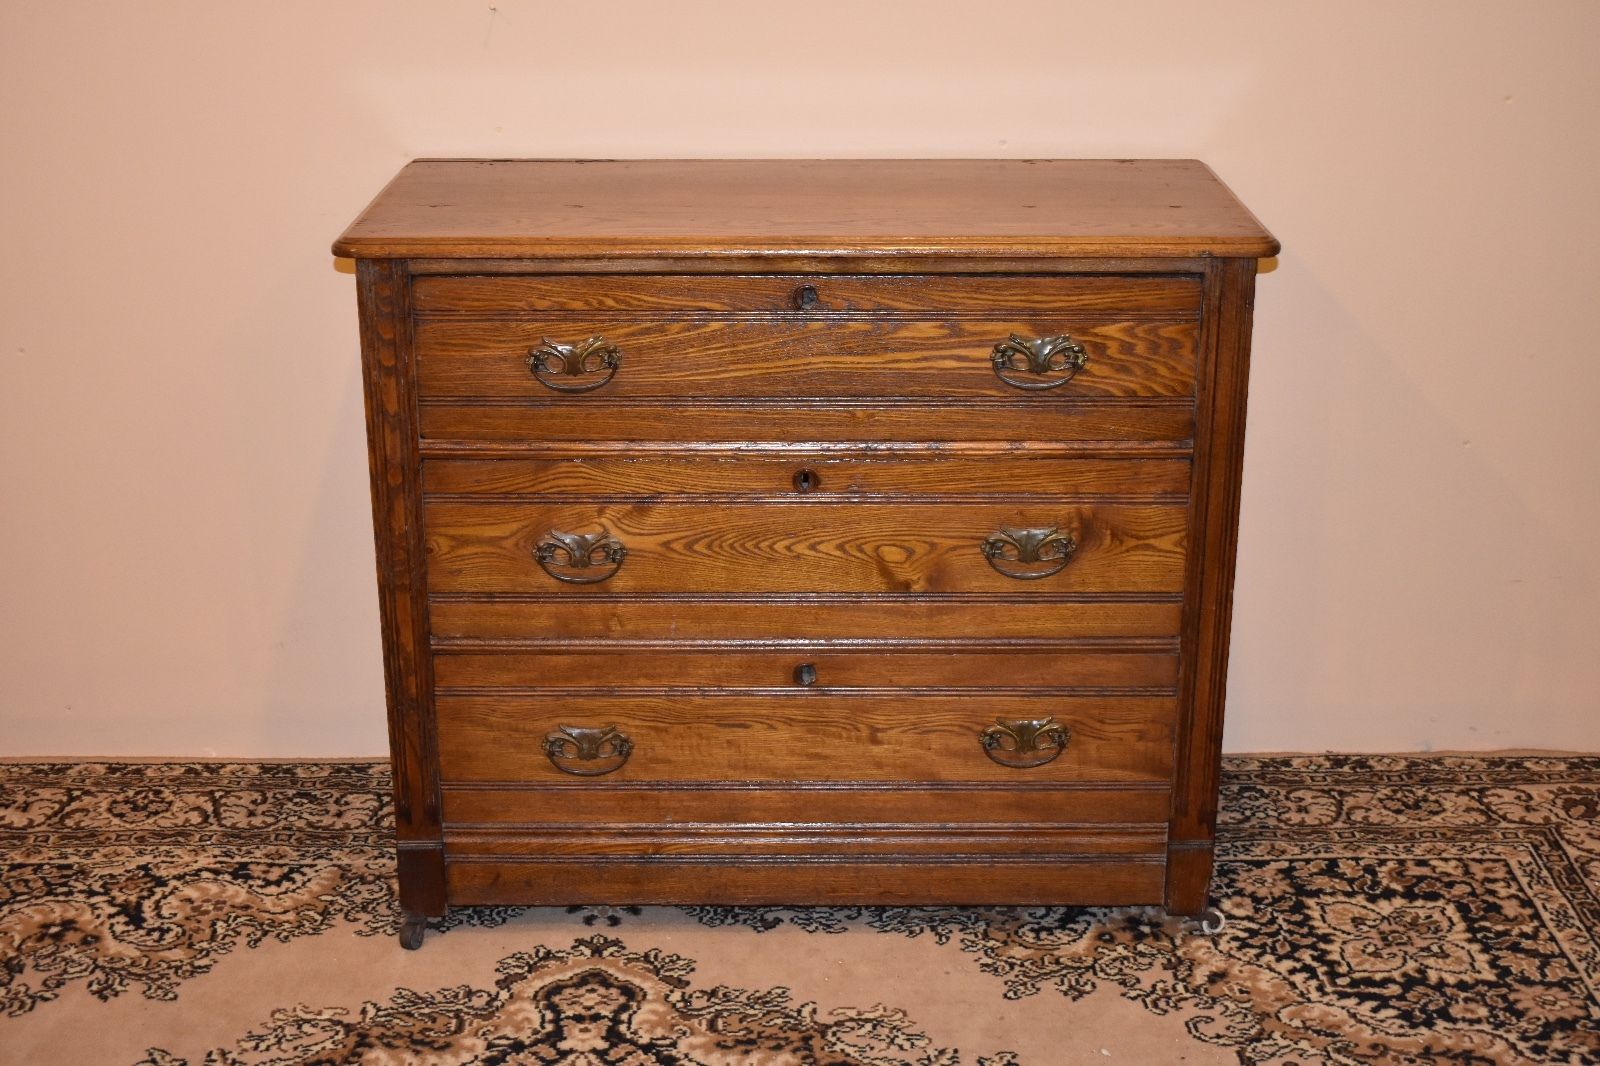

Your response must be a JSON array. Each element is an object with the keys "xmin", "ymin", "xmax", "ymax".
[{"xmin": 0, "ymin": 757, "xmax": 1600, "ymax": 1066}]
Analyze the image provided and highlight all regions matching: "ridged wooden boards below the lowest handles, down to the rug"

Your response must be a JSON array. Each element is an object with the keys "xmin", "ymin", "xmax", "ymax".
[{"xmin": 443, "ymin": 784, "xmax": 1170, "ymax": 904}]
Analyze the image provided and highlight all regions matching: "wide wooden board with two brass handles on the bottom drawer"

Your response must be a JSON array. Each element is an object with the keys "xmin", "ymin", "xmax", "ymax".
[{"xmin": 435, "ymin": 690, "xmax": 1176, "ymax": 784}]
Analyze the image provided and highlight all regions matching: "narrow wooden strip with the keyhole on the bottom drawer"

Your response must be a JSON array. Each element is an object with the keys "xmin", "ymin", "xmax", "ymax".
[{"xmin": 434, "ymin": 647, "xmax": 1178, "ymax": 691}]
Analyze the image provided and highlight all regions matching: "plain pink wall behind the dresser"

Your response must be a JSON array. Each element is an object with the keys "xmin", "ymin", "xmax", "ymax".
[{"xmin": 0, "ymin": 0, "xmax": 1600, "ymax": 755}]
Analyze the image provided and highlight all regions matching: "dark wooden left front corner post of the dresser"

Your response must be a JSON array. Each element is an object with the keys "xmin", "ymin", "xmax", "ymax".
[{"xmin": 357, "ymin": 259, "xmax": 445, "ymax": 914}]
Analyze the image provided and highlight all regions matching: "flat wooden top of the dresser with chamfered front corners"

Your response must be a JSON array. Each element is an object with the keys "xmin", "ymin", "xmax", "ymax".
[{"xmin": 333, "ymin": 158, "xmax": 1278, "ymax": 259}]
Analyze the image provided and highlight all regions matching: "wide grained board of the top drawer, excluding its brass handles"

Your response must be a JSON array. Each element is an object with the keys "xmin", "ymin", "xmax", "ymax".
[{"xmin": 416, "ymin": 315, "xmax": 1195, "ymax": 405}]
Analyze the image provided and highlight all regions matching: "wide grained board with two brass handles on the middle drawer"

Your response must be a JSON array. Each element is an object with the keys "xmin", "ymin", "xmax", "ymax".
[{"xmin": 424, "ymin": 499, "xmax": 1187, "ymax": 595}]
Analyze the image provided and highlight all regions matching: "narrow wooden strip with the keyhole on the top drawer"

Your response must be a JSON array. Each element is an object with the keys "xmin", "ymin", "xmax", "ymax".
[{"xmin": 413, "ymin": 272, "xmax": 1200, "ymax": 319}]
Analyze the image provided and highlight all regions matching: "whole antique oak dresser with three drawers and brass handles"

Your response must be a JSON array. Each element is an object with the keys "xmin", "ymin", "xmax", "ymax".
[{"xmin": 334, "ymin": 160, "xmax": 1278, "ymax": 948}]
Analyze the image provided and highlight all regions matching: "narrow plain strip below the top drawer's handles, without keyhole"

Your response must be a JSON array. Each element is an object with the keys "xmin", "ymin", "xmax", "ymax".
[{"xmin": 419, "ymin": 397, "xmax": 1194, "ymax": 444}]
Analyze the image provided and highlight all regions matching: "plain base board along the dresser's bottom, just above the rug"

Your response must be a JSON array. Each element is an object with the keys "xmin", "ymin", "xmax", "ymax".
[{"xmin": 448, "ymin": 855, "xmax": 1162, "ymax": 906}]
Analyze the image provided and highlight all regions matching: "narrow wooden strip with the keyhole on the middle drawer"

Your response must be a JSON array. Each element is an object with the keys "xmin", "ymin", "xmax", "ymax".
[{"xmin": 422, "ymin": 455, "xmax": 1189, "ymax": 499}]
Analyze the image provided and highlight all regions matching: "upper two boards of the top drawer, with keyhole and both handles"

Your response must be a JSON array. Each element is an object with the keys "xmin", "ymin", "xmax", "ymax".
[{"xmin": 416, "ymin": 275, "xmax": 1198, "ymax": 402}]
